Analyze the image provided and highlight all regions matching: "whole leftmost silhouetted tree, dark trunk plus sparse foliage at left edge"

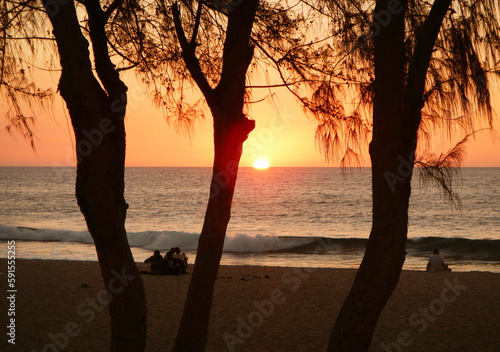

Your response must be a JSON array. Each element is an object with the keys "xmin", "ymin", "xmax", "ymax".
[{"xmin": 2, "ymin": 0, "xmax": 146, "ymax": 351}]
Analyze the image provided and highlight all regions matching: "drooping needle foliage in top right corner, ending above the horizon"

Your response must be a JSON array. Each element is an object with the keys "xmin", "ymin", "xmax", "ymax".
[{"xmin": 409, "ymin": 0, "xmax": 500, "ymax": 142}]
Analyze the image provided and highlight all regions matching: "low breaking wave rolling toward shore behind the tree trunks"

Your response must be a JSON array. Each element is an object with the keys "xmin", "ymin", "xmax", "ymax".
[{"xmin": 0, "ymin": 225, "xmax": 500, "ymax": 261}]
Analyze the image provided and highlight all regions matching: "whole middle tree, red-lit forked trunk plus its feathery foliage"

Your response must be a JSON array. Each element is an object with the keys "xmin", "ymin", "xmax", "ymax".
[{"xmin": 122, "ymin": 0, "xmax": 342, "ymax": 351}]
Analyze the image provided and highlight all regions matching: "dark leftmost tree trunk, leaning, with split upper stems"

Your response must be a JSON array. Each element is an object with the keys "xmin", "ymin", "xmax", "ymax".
[{"xmin": 44, "ymin": 0, "xmax": 146, "ymax": 352}]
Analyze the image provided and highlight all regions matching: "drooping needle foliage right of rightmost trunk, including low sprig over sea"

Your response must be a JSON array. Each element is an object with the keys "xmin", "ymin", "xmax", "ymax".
[{"xmin": 408, "ymin": 0, "xmax": 500, "ymax": 198}]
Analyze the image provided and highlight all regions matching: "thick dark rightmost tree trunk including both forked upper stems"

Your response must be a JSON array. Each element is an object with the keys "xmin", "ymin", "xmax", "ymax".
[{"xmin": 328, "ymin": 0, "xmax": 451, "ymax": 352}]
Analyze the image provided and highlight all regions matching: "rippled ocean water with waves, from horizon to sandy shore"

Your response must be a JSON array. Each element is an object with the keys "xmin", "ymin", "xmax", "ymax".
[{"xmin": 0, "ymin": 167, "xmax": 500, "ymax": 273}]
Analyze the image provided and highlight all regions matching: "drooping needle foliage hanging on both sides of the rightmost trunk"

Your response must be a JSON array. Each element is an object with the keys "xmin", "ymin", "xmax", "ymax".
[{"xmin": 304, "ymin": 0, "xmax": 500, "ymax": 182}]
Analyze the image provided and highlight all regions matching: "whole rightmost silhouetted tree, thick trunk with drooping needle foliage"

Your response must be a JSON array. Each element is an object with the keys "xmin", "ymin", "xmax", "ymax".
[{"xmin": 304, "ymin": 0, "xmax": 500, "ymax": 351}]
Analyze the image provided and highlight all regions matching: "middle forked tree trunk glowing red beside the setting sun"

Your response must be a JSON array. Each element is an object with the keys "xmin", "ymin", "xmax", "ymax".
[{"xmin": 173, "ymin": 0, "xmax": 258, "ymax": 352}]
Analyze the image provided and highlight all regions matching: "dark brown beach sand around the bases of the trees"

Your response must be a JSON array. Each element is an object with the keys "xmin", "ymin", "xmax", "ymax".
[{"xmin": 0, "ymin": 259, "xmax": 500, "ymax": 352}]
